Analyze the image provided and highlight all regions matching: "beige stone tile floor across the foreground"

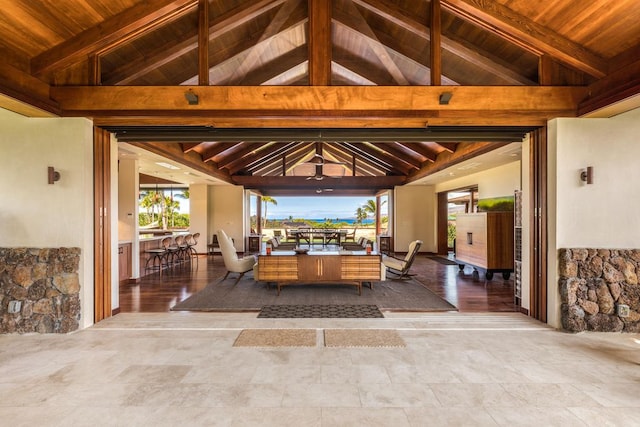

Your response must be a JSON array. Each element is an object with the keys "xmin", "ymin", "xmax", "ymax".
[{"xmin": 0, "ymin": 313, "xmax": 640, "ymax": 427}]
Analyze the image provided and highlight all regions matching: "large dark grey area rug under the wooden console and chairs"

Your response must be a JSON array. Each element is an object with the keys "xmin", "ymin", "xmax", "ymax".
[{"xmin": 171, "ymin": 276, "xmax": 456, "ymax": 311}]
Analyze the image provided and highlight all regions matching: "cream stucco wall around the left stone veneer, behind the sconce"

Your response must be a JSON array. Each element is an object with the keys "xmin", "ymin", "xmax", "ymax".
[{"xmin": 0, "ymin": 109, "xmax": 93, "ymax": 327}]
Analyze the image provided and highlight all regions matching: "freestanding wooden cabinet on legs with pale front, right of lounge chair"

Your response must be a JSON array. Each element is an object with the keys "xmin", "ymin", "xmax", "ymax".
[{"xmin": 456, "ymin": 212, "xmax": 514, "ymax": 279}]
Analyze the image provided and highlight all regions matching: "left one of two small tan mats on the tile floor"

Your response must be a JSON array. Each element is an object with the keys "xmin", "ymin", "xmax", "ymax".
[{"xmin": 233, "ymin": 329, "xmax": 317, "ymax": 347}]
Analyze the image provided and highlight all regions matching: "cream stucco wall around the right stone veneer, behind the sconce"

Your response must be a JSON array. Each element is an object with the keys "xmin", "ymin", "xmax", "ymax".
[{"xmin": 548, "ymin": 109, "xmax": 640, "ymax": 327}]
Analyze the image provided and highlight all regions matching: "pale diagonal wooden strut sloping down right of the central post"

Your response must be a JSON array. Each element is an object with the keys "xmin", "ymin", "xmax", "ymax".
[{"xmin": 334, "ymin": 0, "xmax": 409, "ymax": 85}]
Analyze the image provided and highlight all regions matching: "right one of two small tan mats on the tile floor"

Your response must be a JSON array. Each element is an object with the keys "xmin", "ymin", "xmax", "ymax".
[{"xmin": 324, "ymin": 329, "xmax": 405, "ymax": 347}]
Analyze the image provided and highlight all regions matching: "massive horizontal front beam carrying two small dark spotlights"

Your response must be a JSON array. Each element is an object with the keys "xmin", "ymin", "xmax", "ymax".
[{"xmin": 51, "ymin": 86, "xmax": 585, "ymax": 128}]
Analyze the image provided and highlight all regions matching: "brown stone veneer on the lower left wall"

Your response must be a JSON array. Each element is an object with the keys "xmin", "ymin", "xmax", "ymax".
[{"xmin": 0, "ymin": 248, "xmax": 80, "ymax": 334}]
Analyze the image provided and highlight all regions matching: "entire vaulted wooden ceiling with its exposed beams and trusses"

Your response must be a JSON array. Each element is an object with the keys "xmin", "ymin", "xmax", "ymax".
[{"xmin": 0, "ymin": 0, "xmax": 640, "ymax": 194}]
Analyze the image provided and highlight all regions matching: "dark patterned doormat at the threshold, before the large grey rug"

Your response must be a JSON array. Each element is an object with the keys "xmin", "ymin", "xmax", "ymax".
[{"xmin": 258, "ymin": 304, "xmax": 384, "ymax": 318}]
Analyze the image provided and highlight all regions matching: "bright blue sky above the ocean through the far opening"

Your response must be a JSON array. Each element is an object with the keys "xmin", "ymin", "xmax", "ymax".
[{"xmin": 251, "ymin": 196, "xmax": 386, "ymax": 219}]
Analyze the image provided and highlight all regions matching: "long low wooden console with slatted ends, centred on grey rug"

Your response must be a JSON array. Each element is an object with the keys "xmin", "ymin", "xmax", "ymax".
[{"xmin": 257, "ymin": 251, "xmax": 382, "ymax": 295}]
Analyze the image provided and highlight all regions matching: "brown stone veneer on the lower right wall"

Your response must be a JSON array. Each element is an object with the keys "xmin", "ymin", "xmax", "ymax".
[{"xmin": 558, "ymin": 249, "xmax": 640, "ymax": 332}]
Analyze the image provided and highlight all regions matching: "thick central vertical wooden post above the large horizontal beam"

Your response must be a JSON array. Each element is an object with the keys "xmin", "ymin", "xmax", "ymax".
[{"xmin": 307, "ymin": 0, "xmax": 332, "ymax": 86}]
